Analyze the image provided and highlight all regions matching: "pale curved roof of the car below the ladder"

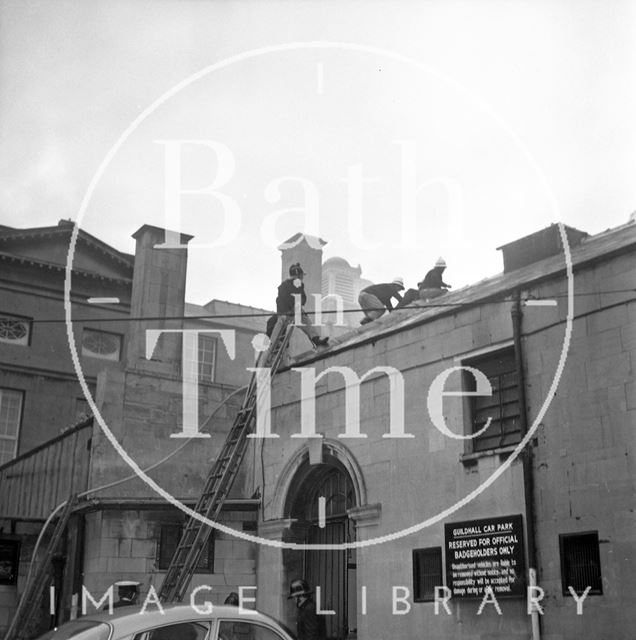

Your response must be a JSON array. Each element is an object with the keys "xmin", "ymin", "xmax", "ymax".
[{"xmin": 81, "ymin": 604, "xmax": 281, "ymax": 632}]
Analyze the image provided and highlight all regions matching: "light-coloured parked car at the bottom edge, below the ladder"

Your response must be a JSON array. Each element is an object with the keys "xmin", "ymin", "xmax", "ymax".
[{"xmin": 39, "ymin": 605, "xmax": 294, "ymax": 640}]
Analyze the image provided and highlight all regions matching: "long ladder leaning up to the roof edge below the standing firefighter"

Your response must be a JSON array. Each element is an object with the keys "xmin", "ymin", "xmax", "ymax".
[{"xmin": 158, "ymin": 316, "xmax": 293, "ymax": 602}]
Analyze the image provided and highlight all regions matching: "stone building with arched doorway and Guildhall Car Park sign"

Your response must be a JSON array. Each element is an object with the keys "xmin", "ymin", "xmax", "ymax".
[{"xmin": 248, "ymin": 223, "xmax": 636, "ymax": 640}]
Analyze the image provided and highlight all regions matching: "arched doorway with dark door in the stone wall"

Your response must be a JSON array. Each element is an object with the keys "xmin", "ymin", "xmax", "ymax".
[{"xmin": 286, "ymin": 456, "xmax": 357, "ymax": 640}]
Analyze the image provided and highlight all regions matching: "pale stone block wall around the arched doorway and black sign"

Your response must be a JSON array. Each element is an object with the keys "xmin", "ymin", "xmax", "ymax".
[{"xmin": 254, "ymin": 248, "xmax": 636, "ymax": 640}]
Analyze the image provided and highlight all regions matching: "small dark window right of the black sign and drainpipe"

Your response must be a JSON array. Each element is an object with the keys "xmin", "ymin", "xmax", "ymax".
[{"xmin": 559, "ymin": 532, "xmax": 603, "ymax": 596}]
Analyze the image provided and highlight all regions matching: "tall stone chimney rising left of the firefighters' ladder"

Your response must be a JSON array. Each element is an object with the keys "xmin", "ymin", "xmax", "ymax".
[{"xmin": 127, "ymin": 224, "xmax": 193, "ymax": 374}]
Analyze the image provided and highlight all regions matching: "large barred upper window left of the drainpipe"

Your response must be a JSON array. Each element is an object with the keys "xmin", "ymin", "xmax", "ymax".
[{"xmin": 462, "ymin": 349, "xmax": 521, "ymax": 451}]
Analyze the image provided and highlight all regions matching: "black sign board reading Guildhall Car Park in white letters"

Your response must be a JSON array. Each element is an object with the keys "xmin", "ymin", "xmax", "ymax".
[{"xmin": 444, "ymin": 515, "xmax": 526, "ymax": 598}]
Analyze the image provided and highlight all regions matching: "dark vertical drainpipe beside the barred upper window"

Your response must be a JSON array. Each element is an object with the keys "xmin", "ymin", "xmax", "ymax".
[{"xmin": 511, "ymin": 290, "xmax": 541, "ymax": 640}]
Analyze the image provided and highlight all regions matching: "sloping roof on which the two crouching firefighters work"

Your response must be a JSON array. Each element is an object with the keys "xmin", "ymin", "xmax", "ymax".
[{"xmin": 295, "ymin": 222, "xmax": 636, "ymax": 364}]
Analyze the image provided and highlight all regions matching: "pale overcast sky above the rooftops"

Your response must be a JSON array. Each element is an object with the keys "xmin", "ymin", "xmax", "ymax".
[{"xmin": 0, "ymin": 0, "xmax": 636, "ymax": 308}]
